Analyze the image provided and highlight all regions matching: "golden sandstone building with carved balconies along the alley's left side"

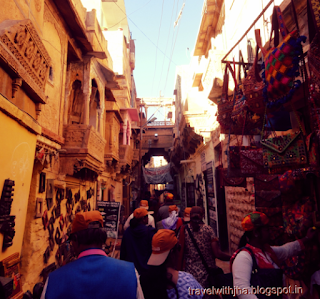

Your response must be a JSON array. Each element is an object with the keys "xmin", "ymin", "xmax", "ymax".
[{"xmin": 0, "ymin": 0, "xmax": 138, "ymax": 292}]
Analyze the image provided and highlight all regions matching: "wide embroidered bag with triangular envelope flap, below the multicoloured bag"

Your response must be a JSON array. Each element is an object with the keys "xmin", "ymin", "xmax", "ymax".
[{"xmin": 260, "ymin": 132, "xmax": 307, "ymax": 173}]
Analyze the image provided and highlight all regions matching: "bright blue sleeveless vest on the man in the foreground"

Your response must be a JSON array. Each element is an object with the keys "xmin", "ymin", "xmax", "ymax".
[{"xmin": 45, "ymin": 255, "xmax": 137, "ymax": 299}]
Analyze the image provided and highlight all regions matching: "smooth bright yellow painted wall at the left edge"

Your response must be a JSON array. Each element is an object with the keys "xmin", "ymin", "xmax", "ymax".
[{"xmin": 0, "ymin": 112, "xmax": 36, "ymax": 260}]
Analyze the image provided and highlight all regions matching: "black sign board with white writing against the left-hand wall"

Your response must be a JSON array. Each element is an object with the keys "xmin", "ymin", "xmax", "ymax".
[{"xmin": 97, "ymin": 201, "xmax": 120, "ymax": 239}]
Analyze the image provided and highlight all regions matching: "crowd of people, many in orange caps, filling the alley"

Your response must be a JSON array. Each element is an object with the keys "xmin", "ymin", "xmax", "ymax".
[{"xmin": 41, "ymin": 195, "xmax": 316, "ymax": 299}]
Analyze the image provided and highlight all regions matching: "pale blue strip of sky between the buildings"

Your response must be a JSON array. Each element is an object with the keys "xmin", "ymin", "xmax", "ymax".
[{"xmin": 125, "ymin": 0, "xmax": 204, "ymax": 98}]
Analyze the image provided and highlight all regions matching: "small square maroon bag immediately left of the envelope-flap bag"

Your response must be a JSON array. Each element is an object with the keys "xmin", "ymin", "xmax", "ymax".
[{"xmin": 240, "ymin": 147, "xmax": 265, "ymax": 175}]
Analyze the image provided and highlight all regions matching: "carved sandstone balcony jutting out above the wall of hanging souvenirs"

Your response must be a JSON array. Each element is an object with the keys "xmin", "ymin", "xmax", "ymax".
[{"xmin": 60, "ymin": 124, "xmax": 106, "ymax": 175}]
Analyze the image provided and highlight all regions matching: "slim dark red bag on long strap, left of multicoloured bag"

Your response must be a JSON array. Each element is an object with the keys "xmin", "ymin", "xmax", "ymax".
[{"xmin": 243, "ymin": 29, "xmax": 265, "ymax": 117}]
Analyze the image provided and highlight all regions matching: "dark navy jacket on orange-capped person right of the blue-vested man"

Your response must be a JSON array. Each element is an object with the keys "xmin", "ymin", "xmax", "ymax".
[{"xmin": 120, "ymin": 224, "xmax": 156, "ymax": 275}]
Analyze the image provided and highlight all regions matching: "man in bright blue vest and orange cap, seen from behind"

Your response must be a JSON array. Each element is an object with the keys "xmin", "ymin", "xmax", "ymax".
[{"xmin": 41, "ymin": 211, "xmax": 144, "ymax": 299}]
